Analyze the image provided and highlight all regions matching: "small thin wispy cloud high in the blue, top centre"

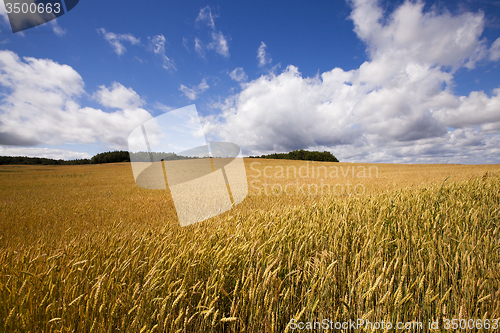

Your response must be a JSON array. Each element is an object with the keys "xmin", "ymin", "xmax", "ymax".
[{"xmin": 194, "ymin": 6, "xmax": 229, "ymax": 58}]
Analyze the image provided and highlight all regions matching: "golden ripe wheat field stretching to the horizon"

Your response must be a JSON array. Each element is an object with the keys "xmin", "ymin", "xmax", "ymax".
[{"xmin": 0, "ymin": 159, "xmax": 500, "ymax": 332}]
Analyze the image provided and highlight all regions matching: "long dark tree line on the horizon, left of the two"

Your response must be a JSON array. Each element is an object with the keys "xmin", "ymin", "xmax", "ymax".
[{"xmin": 0, "ymin": 150, "xmax": 196, "ymax": 165}]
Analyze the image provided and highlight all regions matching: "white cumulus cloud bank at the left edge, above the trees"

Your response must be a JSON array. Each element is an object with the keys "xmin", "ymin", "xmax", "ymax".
[{"xmin": 0, "ymin": 51, "xmax": 151, "ymax": 149}]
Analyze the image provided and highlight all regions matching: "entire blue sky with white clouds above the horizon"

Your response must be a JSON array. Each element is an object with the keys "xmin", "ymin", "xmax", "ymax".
[{"xmin": 0, "ymin": 0, "xmax": 500, "ymax": 163}]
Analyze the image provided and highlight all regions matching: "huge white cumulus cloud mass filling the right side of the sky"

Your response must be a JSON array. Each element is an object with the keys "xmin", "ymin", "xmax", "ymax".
[{"xmin": 204, "ymin": 0, "xmax": 500, "ymax": 163}]
